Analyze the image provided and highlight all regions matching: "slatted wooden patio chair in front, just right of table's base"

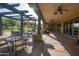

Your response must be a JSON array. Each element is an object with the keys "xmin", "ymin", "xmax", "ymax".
[{"xmin": 14, "ymin": 38, "xmax": 26, "ymax": 56}]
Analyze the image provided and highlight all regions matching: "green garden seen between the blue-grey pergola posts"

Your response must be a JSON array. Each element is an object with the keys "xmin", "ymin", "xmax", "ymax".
[{"xmin": 2, "ymin": 18, "xmax": 38, "ymax": 33}]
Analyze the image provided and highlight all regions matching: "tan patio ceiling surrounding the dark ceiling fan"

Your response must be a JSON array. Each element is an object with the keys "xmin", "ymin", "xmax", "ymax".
[{"xmin": 38, "ymin": 3, "xmax": 79, "ymax": 23}]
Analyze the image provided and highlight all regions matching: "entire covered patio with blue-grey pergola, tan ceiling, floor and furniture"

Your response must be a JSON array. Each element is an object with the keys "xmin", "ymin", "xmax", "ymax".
[{"xmin": 0, "ymin": 3, "xmax": 79, "ymax": 56}]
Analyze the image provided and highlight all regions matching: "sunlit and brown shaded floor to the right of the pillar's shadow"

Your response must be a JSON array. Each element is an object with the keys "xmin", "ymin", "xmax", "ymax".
[{"xmin": 43, "ymin": 32, "xmax": 79, "ymax": 56}]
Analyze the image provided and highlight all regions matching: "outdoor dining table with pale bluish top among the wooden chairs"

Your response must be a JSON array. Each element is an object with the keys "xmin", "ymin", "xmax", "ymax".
[{"xmin": 0, "ymin": 32, "xmax": 27, "ymax": 56}]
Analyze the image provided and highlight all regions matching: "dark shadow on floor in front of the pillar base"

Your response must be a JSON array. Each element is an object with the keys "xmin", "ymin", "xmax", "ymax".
[{"xmin": 27, "ymin": 41, "xmax": 54, "ymax": 56}]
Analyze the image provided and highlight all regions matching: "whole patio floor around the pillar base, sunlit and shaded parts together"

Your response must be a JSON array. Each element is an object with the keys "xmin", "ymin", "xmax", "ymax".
[{"xmin": 0, "ymin": 32, "xmax": 79, "ymax": 56}]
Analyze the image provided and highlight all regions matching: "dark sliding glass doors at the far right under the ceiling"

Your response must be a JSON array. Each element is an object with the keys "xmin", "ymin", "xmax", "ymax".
[{"xmin": 63, "ymin": 18, "xmax": 79, "ymax": 37}]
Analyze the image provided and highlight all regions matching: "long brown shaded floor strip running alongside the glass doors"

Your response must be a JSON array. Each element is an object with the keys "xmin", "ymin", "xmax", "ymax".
[{"xmin": 48, "ymin": 32, "xmax": 79, "ymax": 56}]
